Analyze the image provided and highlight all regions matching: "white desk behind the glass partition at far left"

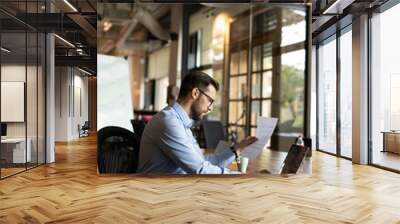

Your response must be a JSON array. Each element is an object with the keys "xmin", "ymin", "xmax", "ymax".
[{"xmin": 1, "ymin": 138, "xmax": 32, "ymax": 163}]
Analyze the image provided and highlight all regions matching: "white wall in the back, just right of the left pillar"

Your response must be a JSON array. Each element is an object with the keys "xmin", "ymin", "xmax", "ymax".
[{"xmin": 55, "ymin": 67, "xmax": 89, "ymax": 141}]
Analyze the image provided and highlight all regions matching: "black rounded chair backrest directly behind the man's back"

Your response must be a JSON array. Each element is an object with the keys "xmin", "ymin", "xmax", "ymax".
[{"xmin": 97, "ymin": 126, "xmax": 139, "ymax": 173}]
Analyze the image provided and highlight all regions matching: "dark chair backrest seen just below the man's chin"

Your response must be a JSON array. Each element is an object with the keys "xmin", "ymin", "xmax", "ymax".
[{"xmin": 202, "ymin": 120, "xmax": 226, "ymax": 149}]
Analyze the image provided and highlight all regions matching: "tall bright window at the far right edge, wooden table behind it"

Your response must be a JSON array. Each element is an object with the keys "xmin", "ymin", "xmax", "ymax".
[{"xmin": 370, "ymin": 4, "xmax": 400, "ymax": 170}]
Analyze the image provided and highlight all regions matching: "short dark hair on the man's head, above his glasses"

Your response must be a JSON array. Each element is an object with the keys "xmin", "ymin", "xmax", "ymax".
[{"xmin": 179, "ymin": 71, "xmax": 219, "ymax": 98}]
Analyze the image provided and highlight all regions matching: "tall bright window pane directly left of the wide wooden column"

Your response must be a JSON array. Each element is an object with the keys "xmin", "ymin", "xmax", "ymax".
[{"xmin": 340, "ymin": 30, "xmax": 353, "ymax": 158}]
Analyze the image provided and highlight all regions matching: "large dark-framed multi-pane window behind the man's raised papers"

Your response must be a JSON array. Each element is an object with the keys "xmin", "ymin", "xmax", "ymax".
[{"xmin": 228, "ymin": 4, "xmax": 306, "ymax": 151}]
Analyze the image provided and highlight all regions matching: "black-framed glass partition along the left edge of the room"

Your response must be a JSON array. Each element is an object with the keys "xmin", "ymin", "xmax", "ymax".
[{"xmin": 0, "ymin": 1, "xmax": 46, "ymax": 178}]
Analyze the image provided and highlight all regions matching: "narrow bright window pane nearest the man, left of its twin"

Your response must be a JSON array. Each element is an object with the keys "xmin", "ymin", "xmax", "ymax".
[{"xmin": 318, "ymin": 37, "xmax": 336, "ymax": 153}]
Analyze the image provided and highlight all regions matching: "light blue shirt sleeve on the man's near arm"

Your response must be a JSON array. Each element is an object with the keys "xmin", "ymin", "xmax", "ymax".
[{"xmin": 158, "ymin": 118, "xmax": 233, "ymax": 174}]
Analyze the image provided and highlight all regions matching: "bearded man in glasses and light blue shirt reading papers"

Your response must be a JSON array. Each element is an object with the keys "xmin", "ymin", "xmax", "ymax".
[{"xmin": 138, "ymin": 71, "xmax": 256, "ymax": 174}]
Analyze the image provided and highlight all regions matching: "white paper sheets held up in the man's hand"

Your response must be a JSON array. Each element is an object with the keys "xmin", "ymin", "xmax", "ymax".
[{"xmin": 240, "ymin": 117, "xmax": 278, "ymax": 160}]
